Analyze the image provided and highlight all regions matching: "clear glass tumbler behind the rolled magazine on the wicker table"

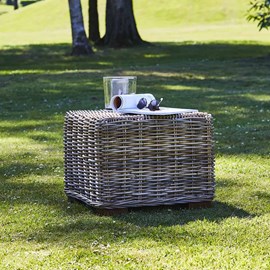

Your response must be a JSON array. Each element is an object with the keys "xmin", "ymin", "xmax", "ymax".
[{"xmin": 103, "ymin": 76, "xmax": 137, "ymax": 109}]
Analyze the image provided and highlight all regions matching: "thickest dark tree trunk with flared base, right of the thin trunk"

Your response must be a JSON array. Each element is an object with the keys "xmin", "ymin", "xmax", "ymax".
[{"xmin": 100, "ymin": 0, "xmax": 147, "ymax": 48}]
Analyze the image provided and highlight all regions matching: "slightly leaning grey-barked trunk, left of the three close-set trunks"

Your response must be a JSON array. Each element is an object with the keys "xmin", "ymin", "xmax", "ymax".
[{"xmin": 68, "ymin": 0, "xmax": 93, "ymax": 55}]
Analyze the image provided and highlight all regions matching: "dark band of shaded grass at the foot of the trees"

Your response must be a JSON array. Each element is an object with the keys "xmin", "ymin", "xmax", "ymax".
[{"xmin": 0, "ymin": 42, "xmax": 270, "ymax": 70}]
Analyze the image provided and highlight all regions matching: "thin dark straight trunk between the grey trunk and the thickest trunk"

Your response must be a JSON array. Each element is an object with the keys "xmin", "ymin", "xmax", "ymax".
[{"xmin": 88, "ymin": 0, "xmax": 100, "ymax": 43}]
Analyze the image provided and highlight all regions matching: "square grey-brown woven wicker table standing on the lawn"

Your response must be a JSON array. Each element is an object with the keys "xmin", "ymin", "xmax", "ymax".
[{"xmin": 64, "ymin": 110, "xmax": 215, "ymax": 209}]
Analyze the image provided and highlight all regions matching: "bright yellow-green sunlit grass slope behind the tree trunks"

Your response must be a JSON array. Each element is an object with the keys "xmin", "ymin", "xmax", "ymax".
[{"xmin": 0, "ymin": 0, "xmax": 270, "ymax": 46}]
